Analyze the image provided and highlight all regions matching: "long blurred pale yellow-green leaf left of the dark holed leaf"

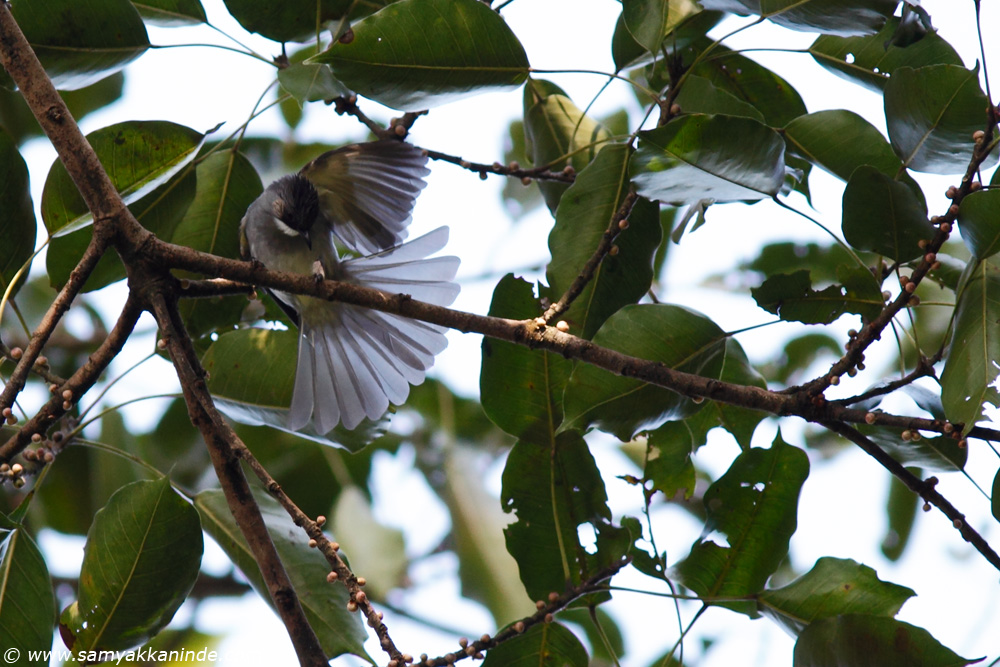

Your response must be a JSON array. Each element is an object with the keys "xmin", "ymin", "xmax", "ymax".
[{"xmin": 440, "ymin": 445, "xmax": 536, "ymax": 627}]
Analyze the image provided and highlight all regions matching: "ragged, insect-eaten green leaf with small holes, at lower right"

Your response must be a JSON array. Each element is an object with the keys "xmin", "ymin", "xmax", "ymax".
[{"xmin": 675, "ymin": 433, "xmax": 809, "ymax": 617}]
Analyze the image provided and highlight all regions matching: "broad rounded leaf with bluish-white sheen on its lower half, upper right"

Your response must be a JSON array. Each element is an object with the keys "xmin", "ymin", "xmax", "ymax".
[{"xmin": 884, "ymin": 65, "xmax": 997, "ymax": 174}]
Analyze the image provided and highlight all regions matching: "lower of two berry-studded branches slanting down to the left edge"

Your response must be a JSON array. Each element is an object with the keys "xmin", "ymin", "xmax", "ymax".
[{"xmin": 0, "ymin": 297, "xmax": 142, "ymax": 463}]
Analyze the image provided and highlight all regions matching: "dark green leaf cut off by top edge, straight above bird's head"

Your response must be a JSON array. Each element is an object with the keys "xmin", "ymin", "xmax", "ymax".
[{"xmin": 225, "ymin": 0, "xmax": 392, "ymax": 42}]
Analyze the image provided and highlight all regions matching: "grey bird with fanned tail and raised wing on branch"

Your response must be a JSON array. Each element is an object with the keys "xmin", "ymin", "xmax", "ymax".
[{"xmin": 240, "ymin": 139, "xmax": 459, "ymax": 435}]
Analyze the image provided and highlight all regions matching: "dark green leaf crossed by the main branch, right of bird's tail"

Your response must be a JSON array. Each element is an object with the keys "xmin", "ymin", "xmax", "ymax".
[{"xmin": 479, "ymin": 274, "xmax": 573, "ymax": 442}]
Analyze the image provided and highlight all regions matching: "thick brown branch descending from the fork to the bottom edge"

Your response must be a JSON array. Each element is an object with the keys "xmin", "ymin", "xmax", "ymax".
[{"xmin": 152, "ymin": 293, "xmax": 327, "ymax": 667}]
